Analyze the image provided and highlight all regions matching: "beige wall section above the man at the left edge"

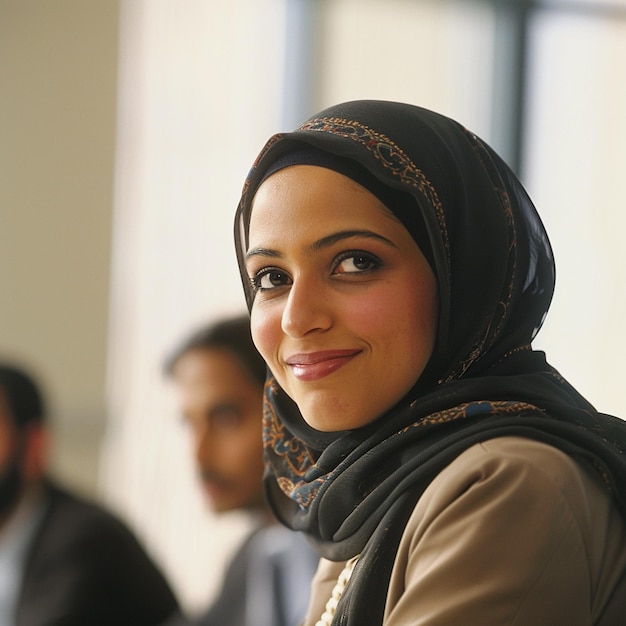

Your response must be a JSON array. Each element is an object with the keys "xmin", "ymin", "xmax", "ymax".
[{"xmin": 0, "ymin": 0, "xmax": 118, "ymax": 498}]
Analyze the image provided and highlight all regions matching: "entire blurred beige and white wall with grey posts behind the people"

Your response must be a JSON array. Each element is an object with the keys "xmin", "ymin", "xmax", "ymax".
[{"xmin": 0, "ymin": 0, "xmax": 626, "ymax": 610}]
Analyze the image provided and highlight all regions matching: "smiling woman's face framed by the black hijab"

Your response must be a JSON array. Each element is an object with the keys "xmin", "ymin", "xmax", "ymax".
[{"xmin": 246, "ymin": 165, "xmax": 437, "ymax": 431}]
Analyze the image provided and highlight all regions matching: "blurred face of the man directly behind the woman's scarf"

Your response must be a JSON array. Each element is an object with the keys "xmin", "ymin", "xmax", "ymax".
[{"xmin": 173, "ymin": 348, "xmax": 263, "ymax": 512}]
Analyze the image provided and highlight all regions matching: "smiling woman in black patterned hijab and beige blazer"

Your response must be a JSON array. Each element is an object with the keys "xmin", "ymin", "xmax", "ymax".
[{"xmin": 230, "ymin": 101, "xmax": 626, "ymax": 626}]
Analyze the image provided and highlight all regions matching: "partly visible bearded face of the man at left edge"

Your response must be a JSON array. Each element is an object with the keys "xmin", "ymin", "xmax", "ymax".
[{"xmin": 0, "ymin": 388, "xmax": 23, "ymax": 525}]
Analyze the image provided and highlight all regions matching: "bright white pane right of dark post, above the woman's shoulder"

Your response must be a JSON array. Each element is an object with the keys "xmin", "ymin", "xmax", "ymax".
[{"xmin": 525, "ymin": 11, "xmax": 626, "ymax": 418}]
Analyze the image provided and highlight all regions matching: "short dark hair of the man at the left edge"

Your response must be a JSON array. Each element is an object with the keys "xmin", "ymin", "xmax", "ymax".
[{"xmin": 0, "ymin": 363, "xmax": 45, "ymax": 430}]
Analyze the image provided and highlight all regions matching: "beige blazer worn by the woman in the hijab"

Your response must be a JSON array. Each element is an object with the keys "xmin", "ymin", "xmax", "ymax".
[{"xmin": 304, "ymin": 437, "xmax": 626, "ymax": 626}]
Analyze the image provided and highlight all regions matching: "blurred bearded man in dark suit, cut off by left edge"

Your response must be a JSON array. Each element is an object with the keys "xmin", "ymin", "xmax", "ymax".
[{"xmin": 0, "ymin": 363, "xmax": 177, "ymax": 626}]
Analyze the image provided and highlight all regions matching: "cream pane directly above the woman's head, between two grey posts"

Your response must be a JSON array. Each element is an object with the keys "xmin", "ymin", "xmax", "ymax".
[{"xmin": 315, "ymin": 0, "xmax": 494, "ymax": 139}]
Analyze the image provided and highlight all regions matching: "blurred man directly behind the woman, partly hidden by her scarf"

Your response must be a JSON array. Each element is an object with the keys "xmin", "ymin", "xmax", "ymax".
[{"xmin": 165, "ymin": 316, "xmax": 318, "ymax": 626}]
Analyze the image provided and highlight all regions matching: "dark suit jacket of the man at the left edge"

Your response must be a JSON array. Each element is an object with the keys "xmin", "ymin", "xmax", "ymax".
[{"xmin": 15, "ymin": 484, "xmax": 177, "ymax": 626}]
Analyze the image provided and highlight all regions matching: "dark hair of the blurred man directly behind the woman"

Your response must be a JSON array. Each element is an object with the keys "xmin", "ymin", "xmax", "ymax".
[{"xmin": 164, "ymin": 315, "xmax": 267, "ymax": 385}]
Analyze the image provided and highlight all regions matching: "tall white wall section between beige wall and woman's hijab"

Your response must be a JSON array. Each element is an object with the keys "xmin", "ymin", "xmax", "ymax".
[{"xmin": 102, "ymin": 0, "xmax": 284, "ymax": 610}]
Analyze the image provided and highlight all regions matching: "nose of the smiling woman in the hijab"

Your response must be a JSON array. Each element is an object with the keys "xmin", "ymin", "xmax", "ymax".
[{"xmin": 281, "ymin": 278, "xmax": 332, "ymax": 337}]
